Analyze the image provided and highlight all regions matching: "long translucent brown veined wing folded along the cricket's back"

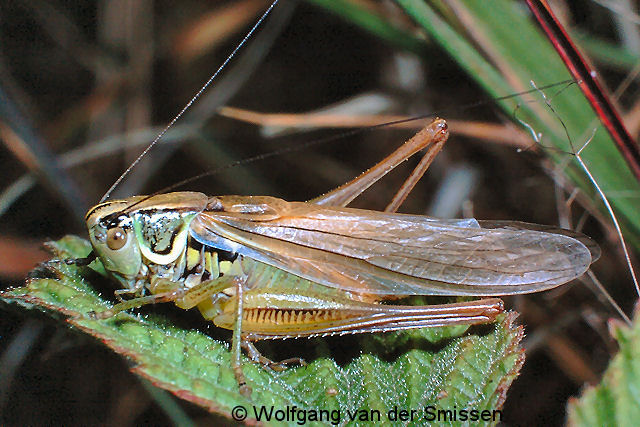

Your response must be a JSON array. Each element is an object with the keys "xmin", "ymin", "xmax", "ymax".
[{"xmin": 192, "ymin": 196, "xmax": 592, "ymax": 296}]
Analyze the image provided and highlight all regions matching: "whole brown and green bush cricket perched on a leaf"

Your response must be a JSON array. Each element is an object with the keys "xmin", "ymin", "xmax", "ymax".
[{"xmin": 80, "ymin": 119, "xmax": 599, "ymax": 395}]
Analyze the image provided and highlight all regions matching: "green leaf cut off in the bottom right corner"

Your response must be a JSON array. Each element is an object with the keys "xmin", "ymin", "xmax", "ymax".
[{"xmin": 568, "ymin": 308, "xmax": 640, "ymax": 427}]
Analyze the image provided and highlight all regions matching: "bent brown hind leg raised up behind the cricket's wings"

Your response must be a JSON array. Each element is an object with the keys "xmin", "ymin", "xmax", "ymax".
[{"xmin": 310, "ymin": 118, "xmax": 449, "ymax": 212}]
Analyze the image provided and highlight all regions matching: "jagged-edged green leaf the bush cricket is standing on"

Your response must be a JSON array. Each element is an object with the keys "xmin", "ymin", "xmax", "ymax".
[{"xmin": 0, "ymin": 236, "xmax": 524, "ymax": 425}]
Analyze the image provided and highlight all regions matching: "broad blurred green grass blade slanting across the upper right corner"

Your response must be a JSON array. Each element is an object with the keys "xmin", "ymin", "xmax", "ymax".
[{"xmin": 318, "ymin": 0, "xmax": 640, "ymax": 246}]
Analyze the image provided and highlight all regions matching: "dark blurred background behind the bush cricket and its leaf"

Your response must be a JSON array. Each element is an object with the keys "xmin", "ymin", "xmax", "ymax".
[{"xmin": 0, "ymin": 0, "xmax": 633, "ymax": 425}]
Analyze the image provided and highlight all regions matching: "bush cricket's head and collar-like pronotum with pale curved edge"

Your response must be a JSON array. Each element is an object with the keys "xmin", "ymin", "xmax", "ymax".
[{"xmin": 85, "ymin": 192, "xmax": 207, "ymax": 290}]
